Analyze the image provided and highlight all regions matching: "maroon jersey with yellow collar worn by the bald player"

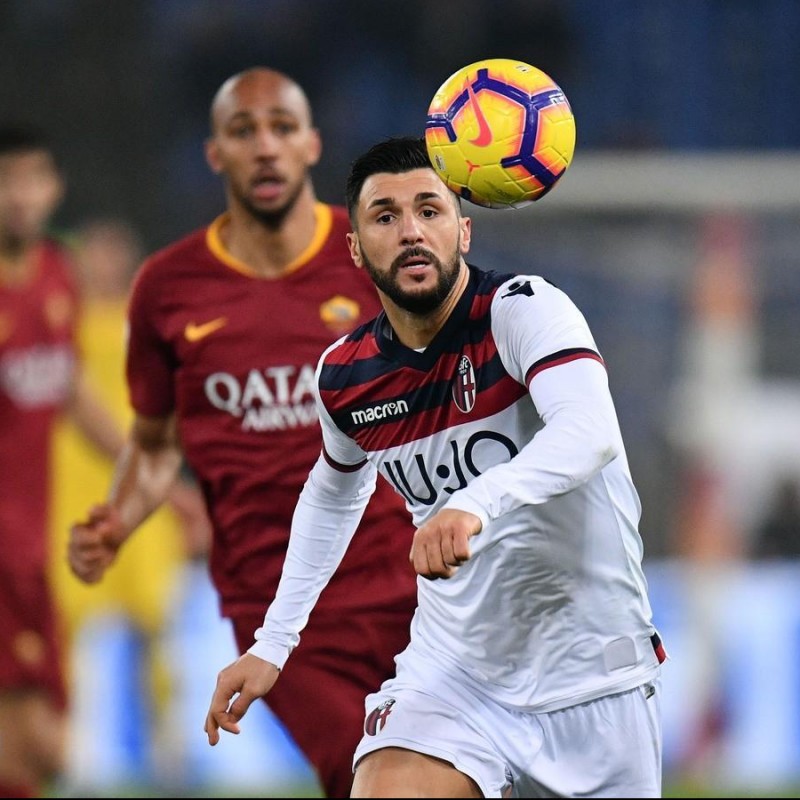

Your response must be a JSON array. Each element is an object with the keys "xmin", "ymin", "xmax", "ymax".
[{"xmin": 127, "ymin": 203, "xmax": 416, "ymax": 615}]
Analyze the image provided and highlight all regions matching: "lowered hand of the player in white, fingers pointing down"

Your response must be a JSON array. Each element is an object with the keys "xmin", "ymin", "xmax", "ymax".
[{"xmin": 204, "ymin": 653, "xmax": 281, "ymax": 747}]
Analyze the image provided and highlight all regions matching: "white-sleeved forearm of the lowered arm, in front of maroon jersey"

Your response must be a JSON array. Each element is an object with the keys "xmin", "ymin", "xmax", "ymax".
[{"xmin": 249, "ymin": 458, "xmax": 376, "ymax": 669}]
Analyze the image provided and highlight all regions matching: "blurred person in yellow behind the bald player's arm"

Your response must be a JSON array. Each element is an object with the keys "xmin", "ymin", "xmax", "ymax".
[{"xmin": 51, "ymin": 219, "xmax": 211, "ymax": 791}]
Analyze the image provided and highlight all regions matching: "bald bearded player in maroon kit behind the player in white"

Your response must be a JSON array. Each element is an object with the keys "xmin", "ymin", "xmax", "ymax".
[{"xmin": 70, "ymin": 68, "xmax": 416, "ymax": 797}]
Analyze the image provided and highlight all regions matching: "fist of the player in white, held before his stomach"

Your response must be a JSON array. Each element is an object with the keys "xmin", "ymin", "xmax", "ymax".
[{"xmin": 409, "ymin": 508, "xmax": 483, "ymax": 578}]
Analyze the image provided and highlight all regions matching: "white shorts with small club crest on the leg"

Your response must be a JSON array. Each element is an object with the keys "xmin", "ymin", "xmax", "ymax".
[{"xmin": 353, "ymin": 662, "xmax": 661, "ymax": 797}]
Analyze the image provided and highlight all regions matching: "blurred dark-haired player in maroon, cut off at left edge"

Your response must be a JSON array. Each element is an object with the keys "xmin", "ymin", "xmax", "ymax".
[{"xmin": 0, "ymin": 127, "xmax": 122, "ymax": 797}]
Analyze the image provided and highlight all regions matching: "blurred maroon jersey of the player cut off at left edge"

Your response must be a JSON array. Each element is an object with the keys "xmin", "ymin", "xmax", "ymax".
[{"xmin": 0, "ymin": 241, "xmax": 77, "ymax": 579}]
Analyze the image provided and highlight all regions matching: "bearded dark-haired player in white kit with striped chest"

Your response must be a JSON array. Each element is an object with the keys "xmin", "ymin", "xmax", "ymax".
[{"xmin": 205, "ymin": 138, "xmax": 665, "ymax": 797}]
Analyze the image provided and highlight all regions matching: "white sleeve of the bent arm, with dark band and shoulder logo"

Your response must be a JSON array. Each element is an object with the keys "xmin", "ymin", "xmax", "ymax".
[{"xmin": 445, "ymin": 278, "xmax": 623, "ymax": 525}]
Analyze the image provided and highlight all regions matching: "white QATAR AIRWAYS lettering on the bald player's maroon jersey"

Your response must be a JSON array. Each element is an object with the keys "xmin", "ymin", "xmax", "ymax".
[{"xmin": 203, "ymin": 364, "xmax": 318, "ymax": 431}]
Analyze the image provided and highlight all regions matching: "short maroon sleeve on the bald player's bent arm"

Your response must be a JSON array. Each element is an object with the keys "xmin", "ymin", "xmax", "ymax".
[{"xmin": 125, "ymin": 264, "xmax": 175, "ymax": 417}]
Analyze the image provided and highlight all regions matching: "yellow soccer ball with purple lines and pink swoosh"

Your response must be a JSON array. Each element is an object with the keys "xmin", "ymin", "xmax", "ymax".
[{"xmin": 425, "ymin": 58, "xmax": 575, "ymax": 208}]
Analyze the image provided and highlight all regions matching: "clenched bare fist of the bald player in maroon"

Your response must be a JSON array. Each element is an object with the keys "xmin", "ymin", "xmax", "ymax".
[{"xmin": 67, "ymin": 503, "xmax": 127, "ymax": 583}]
